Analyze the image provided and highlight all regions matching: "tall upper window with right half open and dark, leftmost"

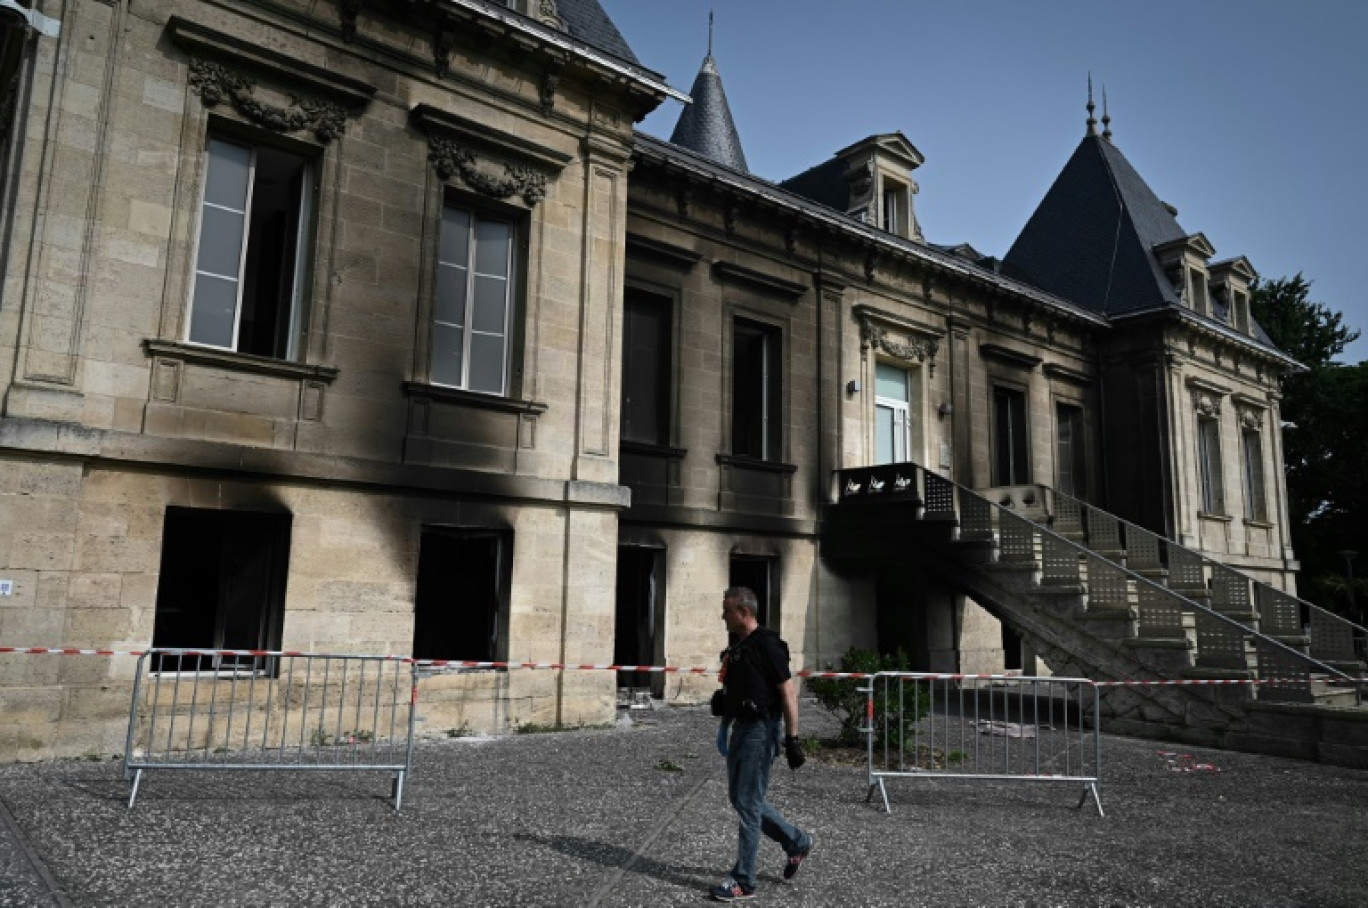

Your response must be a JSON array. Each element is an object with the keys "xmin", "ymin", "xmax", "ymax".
[{"xmin": 186, "ymin": 135, "xmax": 313, "ymax": 360}]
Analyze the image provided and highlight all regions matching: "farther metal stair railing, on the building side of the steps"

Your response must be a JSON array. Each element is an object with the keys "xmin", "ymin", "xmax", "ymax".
[{"xmin": 1041, "ymin": 485, "xmax": 1368, "ymax": 662}]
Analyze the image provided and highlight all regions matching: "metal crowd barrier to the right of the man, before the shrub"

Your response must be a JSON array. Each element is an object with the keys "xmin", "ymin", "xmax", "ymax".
[{"xmin": 860, "ymin": 671, "xmax": 1104, "ymax": 816}]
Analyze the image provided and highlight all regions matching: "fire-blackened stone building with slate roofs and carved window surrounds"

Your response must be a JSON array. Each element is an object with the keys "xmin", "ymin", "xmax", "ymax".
[{"xmin": 0, "ymin": 0, "xmax": 1346, "ymax": 759}]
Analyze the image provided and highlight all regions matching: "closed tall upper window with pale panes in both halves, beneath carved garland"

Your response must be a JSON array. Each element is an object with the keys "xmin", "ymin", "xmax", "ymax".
[{"xmin": 432, "ymin": 205, "xmax": 514, "ymax": 395}]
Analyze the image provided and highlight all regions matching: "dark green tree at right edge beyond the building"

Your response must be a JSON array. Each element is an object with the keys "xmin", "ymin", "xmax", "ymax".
[{"xmin": 1250, "ymin": 273, "xmax": 1368, "ymax": 622}]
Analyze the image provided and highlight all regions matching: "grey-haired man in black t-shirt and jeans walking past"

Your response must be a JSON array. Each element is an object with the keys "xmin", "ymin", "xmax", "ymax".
[{"xmin": 711, "ymin": 587, "xmax": 813, "ymax": 901}]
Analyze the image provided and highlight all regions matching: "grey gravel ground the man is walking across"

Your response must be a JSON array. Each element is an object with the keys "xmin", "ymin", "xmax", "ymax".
[{"xmin": 0, "ymin": 703, "xmax": 1368, "ymax": 908}]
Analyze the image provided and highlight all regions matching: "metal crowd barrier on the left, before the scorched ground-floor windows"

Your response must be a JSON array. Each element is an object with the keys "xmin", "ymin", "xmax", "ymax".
[{"xmin": 123, "ymin": 650, "xmax": 417, "ymax": 810}]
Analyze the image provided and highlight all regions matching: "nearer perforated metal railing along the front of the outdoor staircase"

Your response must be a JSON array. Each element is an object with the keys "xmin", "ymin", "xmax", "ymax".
[{"xmin": 837, "ymin": 462, "xmax": 1363, "ymax": 704}]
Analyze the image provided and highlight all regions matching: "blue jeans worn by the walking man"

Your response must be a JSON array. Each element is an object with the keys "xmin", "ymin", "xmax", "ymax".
[{"xmin": 726, "ymin": 719, "xmax": 813, "ymax": 889}]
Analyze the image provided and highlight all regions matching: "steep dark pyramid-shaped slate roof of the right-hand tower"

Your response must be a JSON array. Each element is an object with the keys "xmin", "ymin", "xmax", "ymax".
[{"xmin": 1003, "ymin": 135, "xmax": 1187, "ymax": 316}]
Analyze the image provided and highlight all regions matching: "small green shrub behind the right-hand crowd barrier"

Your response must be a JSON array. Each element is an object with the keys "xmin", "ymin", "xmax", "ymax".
[{"xmin": 807, "ymin": 647, "xmax": 930, "ymax": 747}]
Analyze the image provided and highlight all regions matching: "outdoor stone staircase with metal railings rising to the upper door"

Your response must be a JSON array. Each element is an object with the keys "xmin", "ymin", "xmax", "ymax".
[{"xmin": 822, "ymin": 464, "xmax": 1368, "ymax": 767}]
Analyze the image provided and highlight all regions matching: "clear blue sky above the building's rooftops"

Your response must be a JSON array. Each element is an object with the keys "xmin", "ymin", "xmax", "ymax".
[{"xmin": 601, "ymin": 0, "xmax": 1368, "ymax": 362}]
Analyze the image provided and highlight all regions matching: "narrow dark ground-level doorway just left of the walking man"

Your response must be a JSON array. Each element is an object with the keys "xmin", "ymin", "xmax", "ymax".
[{"xmin": 613, "ymin": 546, "xmax": 665, "ymax": 697}]
